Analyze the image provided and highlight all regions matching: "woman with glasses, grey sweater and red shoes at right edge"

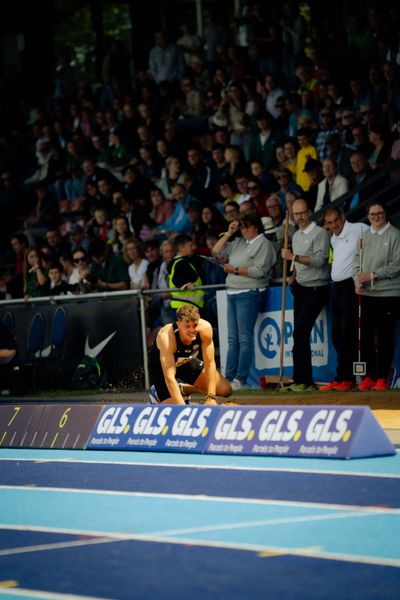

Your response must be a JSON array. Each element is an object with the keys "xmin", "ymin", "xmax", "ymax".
[{"xmin": 353, "ymin": 201, "xmax": 400, "ymax": 391}]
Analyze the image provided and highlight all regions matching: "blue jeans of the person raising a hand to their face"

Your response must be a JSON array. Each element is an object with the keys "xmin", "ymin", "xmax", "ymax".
[{"xmin": 225, "ymin": 290, "xmax": 267, "ymax": 383}]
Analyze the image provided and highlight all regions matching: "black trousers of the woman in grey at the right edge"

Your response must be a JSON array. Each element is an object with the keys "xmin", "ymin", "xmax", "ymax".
[{"xmin": 361, "ymin": 296, "xmax": 400, "ymax": 380}]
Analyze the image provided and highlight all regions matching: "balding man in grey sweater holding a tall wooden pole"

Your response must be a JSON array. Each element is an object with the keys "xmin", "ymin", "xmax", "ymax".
[{"xmin": 281, "ymin": 199, "xmax": 329, "ymax": 392}]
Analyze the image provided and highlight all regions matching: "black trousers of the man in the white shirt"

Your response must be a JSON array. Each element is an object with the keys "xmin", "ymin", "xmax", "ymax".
[{"xmin": 332, "ymin": 279, "xmax": 358, "ymax": 381}]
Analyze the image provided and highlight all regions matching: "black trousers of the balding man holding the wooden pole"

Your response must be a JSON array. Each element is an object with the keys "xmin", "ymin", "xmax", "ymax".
[{"xmin": 291, "ymin": 282, "xmax": 329, "ymax": 385}]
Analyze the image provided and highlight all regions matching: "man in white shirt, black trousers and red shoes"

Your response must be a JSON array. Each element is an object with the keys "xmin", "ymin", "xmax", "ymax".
[{"xmin": 320, "ymin": 207, "xmax": 368, "ymax": 392}]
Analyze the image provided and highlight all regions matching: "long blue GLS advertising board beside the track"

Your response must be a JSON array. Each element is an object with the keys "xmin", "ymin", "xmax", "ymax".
[{"xmin": 87, "ymin": 405, "xmax": 395, "ymax": 458}]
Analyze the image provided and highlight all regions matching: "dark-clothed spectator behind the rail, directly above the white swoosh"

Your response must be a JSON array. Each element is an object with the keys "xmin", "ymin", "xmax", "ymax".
[{"xmin": 87, "ymin": 238, "xmax": 129, "ymax": 292}]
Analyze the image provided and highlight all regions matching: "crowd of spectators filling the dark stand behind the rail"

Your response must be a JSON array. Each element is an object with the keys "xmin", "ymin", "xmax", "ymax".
[{"xmin": 0, "ymin": 1, "xmax": 400, "ymax": 346}]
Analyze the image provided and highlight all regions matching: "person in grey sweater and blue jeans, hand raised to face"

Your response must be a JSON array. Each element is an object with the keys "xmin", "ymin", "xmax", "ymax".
[{"xmin": 212, "ymin": 213, "xmax": 276, "ymax": 389}]
